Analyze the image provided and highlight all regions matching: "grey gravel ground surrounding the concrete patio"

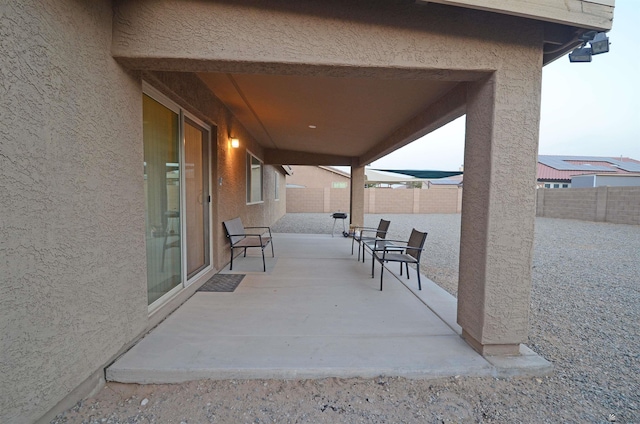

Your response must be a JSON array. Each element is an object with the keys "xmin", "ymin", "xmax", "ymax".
[{"xmin": 52, "ymin": 214, "xmax": 640, "ymax": 424}]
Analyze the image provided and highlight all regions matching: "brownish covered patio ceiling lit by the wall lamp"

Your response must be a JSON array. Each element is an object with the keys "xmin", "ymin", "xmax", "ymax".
[{"xmin": 198, "ymin": 73, "xmax": 468, "ymax": 165}]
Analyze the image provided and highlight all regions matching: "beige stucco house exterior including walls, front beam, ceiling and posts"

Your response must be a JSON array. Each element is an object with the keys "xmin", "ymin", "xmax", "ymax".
[{"xmin": 0, "ymin": 0, "xmax": 612, "ymax": 423}]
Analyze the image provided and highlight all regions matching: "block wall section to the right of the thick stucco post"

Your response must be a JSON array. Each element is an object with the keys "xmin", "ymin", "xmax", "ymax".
[{"xmin": 536, "ymin": 187, "xmax": 640, "ymax": 225}]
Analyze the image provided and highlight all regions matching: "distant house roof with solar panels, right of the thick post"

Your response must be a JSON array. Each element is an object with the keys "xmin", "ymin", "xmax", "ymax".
[{"xmin": 537, "ymin": 155, "xmax": 640, "ymax": 181}]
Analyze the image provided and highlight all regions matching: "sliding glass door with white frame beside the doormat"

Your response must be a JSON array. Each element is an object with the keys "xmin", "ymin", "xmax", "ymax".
[{"xmin": 143, "ymin": 89, "xmax": 211, "ymax": 305}]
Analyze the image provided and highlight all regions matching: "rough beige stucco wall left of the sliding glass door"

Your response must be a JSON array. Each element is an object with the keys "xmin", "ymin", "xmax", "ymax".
[{"xmin": 0, "ymin": 0, "xmax": 148, "ymax": 424}]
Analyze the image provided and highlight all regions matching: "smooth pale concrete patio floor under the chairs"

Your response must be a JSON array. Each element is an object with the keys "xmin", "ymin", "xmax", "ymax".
[{"xmin": 106, "ymin": 234, "xmax": 552, "ymax": 384}]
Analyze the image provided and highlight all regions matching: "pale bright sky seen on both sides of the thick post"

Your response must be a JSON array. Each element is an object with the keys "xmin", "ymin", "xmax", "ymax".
[{"xmin": 371, "ymin": 0, "xmax": 640, "ymax": 171}]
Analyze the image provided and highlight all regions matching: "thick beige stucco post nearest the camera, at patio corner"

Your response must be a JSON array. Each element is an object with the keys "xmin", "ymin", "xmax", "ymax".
[{"xmin": 458, "ymin": 68, "xmax": 541, "ymax": 355}]
